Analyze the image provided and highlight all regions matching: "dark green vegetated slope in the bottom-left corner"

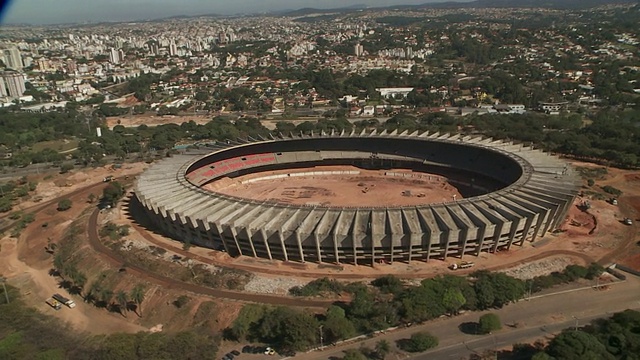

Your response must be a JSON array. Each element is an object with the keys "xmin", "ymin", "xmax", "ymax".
[{"xmin": 0, "ymin": 285, "xmax": 220, "ymax": 360}]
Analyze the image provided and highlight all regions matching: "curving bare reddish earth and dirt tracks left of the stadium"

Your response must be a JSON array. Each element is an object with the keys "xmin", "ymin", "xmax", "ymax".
[{"xmin": 0, "ymin": 163, "xmax": 241, "ymax": 334}]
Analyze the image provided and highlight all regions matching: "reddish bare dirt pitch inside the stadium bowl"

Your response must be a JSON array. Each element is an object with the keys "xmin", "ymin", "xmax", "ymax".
[{"xmin": 205, "ymin": 166, "xmax": 462, "ymax": 207}]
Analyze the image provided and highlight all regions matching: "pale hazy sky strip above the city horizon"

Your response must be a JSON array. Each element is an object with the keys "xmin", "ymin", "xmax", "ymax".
[{"xmin": 0, "ymin": 0, "xmax": 460, "ymax": 24}]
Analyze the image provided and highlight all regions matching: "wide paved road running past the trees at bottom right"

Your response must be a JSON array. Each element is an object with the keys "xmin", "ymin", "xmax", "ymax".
[{"xmin": 295, "ymin": 276, "xmax": 640, "ymax": 360}]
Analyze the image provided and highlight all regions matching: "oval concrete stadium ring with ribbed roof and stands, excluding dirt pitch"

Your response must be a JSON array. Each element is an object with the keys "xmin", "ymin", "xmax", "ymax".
[{"xmin": 134, "ymin": 130, "xmax": 579, "ymax": 264}]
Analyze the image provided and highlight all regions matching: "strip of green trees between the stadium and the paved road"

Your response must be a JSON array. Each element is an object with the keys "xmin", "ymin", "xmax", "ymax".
[{"xmin": 225, "ymin": 264, "xmax": 603, "ymax": 351}]
